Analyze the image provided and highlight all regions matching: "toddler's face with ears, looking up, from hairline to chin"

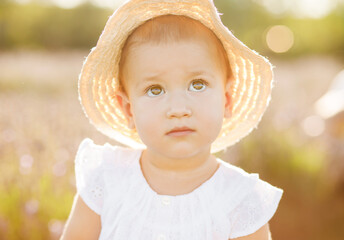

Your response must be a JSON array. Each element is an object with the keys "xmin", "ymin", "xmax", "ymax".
[{"xmin": 117, "ymin": 41, "xmax": 231, "ymax": 158}]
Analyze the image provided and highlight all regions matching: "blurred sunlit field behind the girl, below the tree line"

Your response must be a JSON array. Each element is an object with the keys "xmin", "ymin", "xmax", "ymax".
[{"xmin": 0, "ymin": 51, "xmax": 344, "ymax": 240}]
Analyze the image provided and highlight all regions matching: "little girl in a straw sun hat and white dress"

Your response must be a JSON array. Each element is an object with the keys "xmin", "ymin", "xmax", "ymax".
[{"xmin": 61, "ymin": 0, "xmax": 283, "ymax": 240}]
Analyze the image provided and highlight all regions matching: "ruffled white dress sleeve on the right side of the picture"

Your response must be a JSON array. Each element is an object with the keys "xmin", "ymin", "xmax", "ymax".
[{"xmin": 228, "ymin": 174, "xmax": 283, "ymax": 239}]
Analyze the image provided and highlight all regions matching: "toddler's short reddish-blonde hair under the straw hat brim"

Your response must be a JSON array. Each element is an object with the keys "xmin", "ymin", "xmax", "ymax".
[{"xmin": 119, "ymin": 14, "xmax": 232, "ymax": 93}]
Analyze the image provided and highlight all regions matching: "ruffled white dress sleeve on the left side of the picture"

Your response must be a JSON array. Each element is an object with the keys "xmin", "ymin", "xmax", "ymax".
[{"xmin": 75, "ymin": 138, "xmax": 104, "ymax": 215}]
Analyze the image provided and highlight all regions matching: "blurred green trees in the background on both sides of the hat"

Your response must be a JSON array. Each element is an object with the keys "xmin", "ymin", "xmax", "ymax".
[{"xmin": 0, "ymin": 0, "xmax": 344, "ymax": 56}]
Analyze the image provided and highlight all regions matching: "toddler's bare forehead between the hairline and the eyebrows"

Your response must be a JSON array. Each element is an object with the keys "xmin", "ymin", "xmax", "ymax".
[{"xmin": 124, "ymin": 40, "xmax": 221, "ymax": 84}]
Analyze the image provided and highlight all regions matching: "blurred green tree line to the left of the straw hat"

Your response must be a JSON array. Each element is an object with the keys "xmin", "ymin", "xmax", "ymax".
[{"xmin": 0, "ymin": 4, "xmax": 110, "ymax": 49}]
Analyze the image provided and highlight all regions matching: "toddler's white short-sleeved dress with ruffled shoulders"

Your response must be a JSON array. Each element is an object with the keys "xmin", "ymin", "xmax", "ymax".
[{"xmin": 75, "ymin": 138, "xmax": 283, "ymax": 240}]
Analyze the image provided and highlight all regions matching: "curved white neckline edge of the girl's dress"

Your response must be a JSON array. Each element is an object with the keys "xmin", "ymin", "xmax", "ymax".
[{"xmin": 134, "ymin": 149, "xmax": 223, "ymax": 198}]
